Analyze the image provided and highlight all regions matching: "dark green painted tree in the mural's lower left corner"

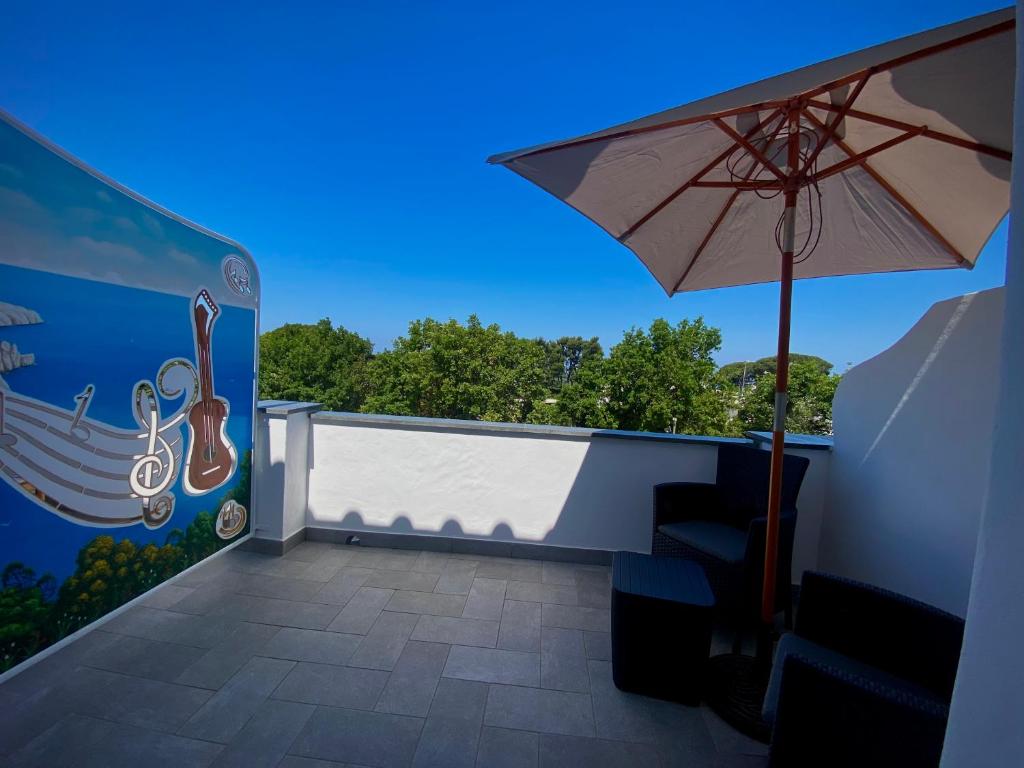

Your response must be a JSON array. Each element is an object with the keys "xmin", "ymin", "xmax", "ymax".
[{"xmin": 0, "ymin": 562, "xmax": 56, "ymax": 672}]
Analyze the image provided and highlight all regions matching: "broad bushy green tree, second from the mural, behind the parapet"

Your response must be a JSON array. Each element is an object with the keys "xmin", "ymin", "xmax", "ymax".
[{"xmin": 362, "ymin": 315, "xmax": 550, "ymax": 422}]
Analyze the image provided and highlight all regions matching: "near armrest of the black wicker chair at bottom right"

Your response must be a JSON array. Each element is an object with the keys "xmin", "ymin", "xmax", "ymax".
[{"xmin": 769, "ymin": 655, "xmax": 949, "ymax": 768}]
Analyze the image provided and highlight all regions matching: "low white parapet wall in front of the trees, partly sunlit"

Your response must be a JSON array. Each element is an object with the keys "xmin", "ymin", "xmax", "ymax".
[{"xmin": 257, "ymin": 404, "xmax": 829, "ymax": 578}]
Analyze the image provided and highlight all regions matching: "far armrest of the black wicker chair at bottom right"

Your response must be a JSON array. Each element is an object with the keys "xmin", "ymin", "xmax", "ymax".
[{"xmin": 794, "ymin": 571, "xmax": 964, "ymax": 701}]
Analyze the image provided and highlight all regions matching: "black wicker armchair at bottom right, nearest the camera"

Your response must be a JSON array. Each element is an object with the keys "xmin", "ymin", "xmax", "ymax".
[{"xmin": 763, "ymin": 571, "xmax": 964, "ymax": 768}]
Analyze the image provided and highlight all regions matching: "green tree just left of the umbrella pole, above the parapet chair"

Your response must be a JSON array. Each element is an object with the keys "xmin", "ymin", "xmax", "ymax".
[{"xmin": 605, "ymin": 317, "xmax": 727, "ymax": 434}]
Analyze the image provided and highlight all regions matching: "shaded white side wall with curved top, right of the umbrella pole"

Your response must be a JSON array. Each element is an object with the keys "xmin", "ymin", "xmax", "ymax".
[{"xmin": 819, "ymin": 288, "xmax": 1004, "ymax": 615}]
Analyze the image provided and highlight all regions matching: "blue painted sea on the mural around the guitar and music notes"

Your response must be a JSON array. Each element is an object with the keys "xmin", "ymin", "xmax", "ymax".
[{"xmin": 0, "ymin": 264, "xmax": 255, "ymax": 582}]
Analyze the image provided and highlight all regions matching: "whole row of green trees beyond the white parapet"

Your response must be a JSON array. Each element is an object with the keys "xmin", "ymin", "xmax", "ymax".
[{"xmin": 259, "ymin": 315, "xmax": 840, "ymax": 435}]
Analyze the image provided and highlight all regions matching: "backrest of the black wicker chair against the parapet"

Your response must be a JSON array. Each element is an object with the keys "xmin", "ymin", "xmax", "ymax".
[{"xmin": 715, "ymin": 443, "xmax": 810, "ymax": 527}]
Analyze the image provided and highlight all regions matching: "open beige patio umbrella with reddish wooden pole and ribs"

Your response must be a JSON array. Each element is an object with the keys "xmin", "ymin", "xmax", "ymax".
[{"xmin": 488, "ymin": 8, "xmax": 1015, "ymax": 638}]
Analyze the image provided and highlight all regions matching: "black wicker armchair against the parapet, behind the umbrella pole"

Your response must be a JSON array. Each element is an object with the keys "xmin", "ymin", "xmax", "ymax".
[{"xmin": 651, "ymin": 444, "xmax": 810, "ymax": 639}]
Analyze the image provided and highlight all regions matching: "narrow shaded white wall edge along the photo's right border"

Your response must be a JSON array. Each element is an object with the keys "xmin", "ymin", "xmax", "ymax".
[{"xmin": 942, "ymin": 0, "xmax": 1024, "ymax": 768}]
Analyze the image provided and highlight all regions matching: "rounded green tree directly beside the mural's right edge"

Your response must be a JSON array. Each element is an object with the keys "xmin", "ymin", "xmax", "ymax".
[{"xmin": 259, "ymin": 317, "xmax": 373, "ymax": 411}]
